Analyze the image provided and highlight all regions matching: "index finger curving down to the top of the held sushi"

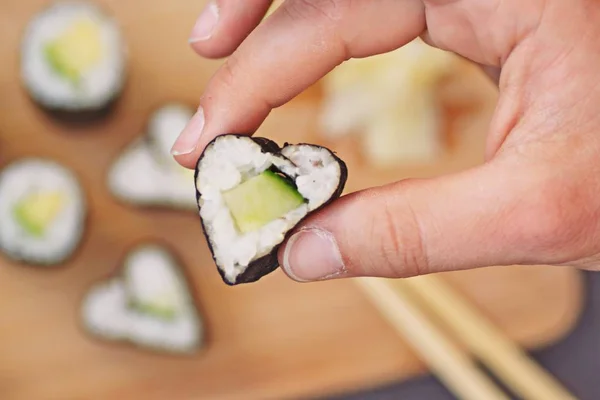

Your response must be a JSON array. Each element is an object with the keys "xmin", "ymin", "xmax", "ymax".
[{"xmin": 172, "ymin": 0, "xmax": 425, "ymax": 168}]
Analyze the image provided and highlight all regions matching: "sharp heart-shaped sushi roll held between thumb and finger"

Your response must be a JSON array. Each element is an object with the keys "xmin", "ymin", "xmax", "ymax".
[{"xmin": 195, "ymin": 134, "xmax": 348, "ymax": 285}]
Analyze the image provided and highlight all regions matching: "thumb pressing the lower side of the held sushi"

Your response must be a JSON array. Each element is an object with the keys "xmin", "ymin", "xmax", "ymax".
[{"xmin": 279, "ymin": 159, "xmax": 543, "ymax": 281}]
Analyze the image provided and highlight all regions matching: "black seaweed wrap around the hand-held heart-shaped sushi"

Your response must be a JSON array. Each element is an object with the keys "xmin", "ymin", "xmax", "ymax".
[{"xmin": 194, "ymin": 133, "xmax": 348, "ymax": 286}]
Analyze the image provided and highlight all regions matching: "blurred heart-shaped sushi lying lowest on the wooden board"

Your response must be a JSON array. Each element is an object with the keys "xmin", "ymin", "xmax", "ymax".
[{"xmin": 81, "ymin": 244, "xmax": 204, "ymax": 354}]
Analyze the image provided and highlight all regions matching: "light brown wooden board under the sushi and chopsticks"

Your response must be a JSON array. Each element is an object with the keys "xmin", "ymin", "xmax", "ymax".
[{"xmin": 0, "ymin": 0, "xmax": 582, "ymax": 400}]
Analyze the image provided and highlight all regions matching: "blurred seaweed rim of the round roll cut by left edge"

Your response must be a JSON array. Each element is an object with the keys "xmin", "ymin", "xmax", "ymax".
[{"xmin": 0, "ymin": 156, "xmax": 92, "ymax": 271}]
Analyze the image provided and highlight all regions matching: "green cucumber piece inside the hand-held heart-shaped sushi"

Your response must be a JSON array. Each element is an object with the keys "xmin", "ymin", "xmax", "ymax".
[{"xmin": 223, "ymin": 170, "xmax": 306, "ymax": 233}]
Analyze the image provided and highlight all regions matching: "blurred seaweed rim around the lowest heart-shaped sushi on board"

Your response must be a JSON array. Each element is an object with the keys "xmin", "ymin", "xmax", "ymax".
[{"xmin": 76, "ymin": 238, "xmax": 212, "ymax": 358}]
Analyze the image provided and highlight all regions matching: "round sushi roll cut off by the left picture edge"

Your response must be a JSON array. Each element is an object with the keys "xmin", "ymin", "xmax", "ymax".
[{"xmin": 0, "ymin": 158, "xmax": 86, "ymax": 265}]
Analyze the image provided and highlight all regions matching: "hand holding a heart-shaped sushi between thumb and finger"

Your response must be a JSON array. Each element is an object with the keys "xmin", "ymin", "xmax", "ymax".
[{"xmin": 173, "ymin": 0, "xmax": 600, "ymax": 281}]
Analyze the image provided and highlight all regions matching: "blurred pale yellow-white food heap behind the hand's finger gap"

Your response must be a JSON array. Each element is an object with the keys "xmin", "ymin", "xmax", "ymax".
[{"xmin": 320, "ymin": 39, "xmax": 457, "ymax": 167}]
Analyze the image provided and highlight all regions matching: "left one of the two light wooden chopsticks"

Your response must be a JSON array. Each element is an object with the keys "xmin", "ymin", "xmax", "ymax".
[{"xmin": 357, "ymin": 278, "xmax": 509, "ymax": 400}]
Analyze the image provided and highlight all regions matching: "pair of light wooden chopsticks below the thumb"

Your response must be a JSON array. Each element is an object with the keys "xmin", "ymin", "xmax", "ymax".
[{"xmin": 356, "ymin": 275, "xmax": 576, "ymax": 400}]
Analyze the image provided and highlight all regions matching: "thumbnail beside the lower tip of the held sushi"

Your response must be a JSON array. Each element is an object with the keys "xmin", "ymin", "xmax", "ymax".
[{"xmin": 283, "ymin": 228, "xmax": 344, "ymax": 282}]
